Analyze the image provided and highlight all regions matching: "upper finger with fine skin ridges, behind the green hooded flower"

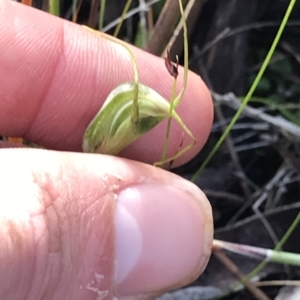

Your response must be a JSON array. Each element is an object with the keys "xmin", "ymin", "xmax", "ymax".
[{"xmin": 0, "ymin": 1, "xmax": 212, "ymax": 163}]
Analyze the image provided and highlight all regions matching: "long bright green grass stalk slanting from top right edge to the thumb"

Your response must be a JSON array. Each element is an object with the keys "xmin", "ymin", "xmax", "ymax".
[{"xmin": 191, "ymin": 0, "xmax": 297, "ymax": 182}]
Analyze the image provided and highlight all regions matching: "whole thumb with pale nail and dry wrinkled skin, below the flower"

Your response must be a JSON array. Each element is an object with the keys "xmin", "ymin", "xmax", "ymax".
[{"xmin": 0, "ymin": 149, "xmax": 213, "ymax": 300}]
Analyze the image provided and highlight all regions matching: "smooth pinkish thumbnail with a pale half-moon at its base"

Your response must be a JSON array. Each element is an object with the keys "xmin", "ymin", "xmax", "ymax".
[{"xmin": 115, "ymin": 184, "xmax": 212, "ymax": 299}]
